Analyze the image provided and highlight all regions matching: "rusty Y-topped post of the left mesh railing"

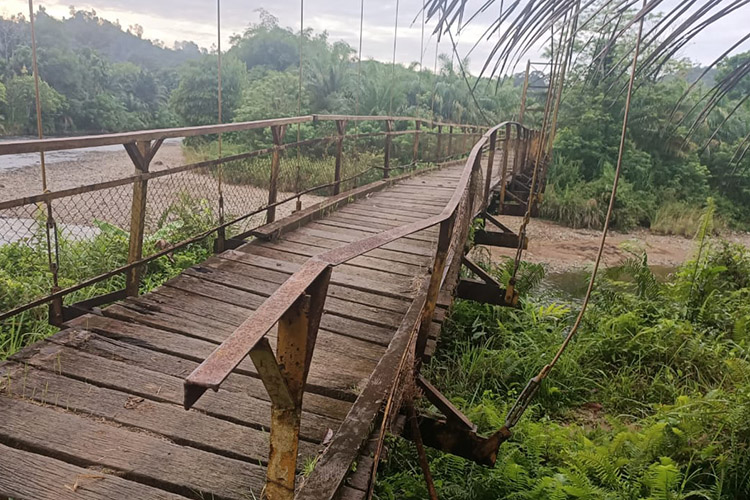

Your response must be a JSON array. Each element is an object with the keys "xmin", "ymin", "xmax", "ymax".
[{"xmin": 125, "ymin": 139, "xmax": 163, "ymax": 297}]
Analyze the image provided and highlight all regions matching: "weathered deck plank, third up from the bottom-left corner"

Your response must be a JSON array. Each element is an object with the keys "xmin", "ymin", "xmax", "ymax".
[{"xmin": 0, "ymin": 365, "xmax": 318, "ymax": 463}]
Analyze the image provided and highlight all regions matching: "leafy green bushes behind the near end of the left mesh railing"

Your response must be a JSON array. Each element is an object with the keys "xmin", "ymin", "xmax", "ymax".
[{"xmin": 0, "ymin": 195, "xmax": 216, "ymax": 360}]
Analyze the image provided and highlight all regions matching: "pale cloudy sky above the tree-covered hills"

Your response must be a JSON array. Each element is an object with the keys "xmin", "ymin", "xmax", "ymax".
[{"xmin": 0, "ymin": 0, "xmax": 750, "ymax": 73}]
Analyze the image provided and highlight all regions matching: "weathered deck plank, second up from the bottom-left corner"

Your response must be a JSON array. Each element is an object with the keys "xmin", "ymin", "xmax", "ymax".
[{"xmin": 0, "ymin": 398, "xmax": 265, "ymax": 499}]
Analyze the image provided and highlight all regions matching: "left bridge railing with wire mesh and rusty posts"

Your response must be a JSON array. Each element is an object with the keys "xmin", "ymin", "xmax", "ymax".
[{"xmin": 0, "ymin": 115, "xmax": 488, "ymax": 329}]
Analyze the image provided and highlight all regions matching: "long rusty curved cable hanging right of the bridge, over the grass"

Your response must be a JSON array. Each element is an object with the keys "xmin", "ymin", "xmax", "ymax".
[{"xmin": 504, "ymin": 0, "xmax": 646, "ymax": 430}]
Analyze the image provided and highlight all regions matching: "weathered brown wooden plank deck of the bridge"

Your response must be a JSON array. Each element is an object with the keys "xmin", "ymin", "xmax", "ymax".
[{"xmin": 0, "ymin": 160, "xmax": 476, "ymax": 500}]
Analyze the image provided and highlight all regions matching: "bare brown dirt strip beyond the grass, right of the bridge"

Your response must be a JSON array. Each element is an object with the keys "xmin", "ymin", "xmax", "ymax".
[{"xmin": 490, "ymin": 216, "xmax": 750, "ymax": 272}]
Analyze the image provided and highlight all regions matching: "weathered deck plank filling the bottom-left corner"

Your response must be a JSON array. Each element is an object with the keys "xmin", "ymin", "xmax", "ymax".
[{"xmin": 0, "ymin": 445, "xmax": 186, "ymax": 500}]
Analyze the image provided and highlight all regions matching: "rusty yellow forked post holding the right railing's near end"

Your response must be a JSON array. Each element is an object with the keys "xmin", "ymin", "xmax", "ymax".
[{"xmin": 258, "ymin": 267, "xmax": 331, "ymax": 500}]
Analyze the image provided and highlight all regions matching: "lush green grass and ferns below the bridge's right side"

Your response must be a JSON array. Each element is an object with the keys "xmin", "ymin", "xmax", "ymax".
[{"xmin": 376, "ymin": 211, "xmax": 750, "ymax": 500}]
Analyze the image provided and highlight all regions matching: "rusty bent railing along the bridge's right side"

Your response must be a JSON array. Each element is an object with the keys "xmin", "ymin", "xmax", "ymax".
[{"xmin": 180, "ymin": 122, "xmax": 535, "ymax": 500}]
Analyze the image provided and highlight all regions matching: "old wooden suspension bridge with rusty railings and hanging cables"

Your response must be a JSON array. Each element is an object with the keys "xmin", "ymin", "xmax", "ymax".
[{"xmin": 0, "ymin": 2, "xmax": 612, "ymax": 500}]
